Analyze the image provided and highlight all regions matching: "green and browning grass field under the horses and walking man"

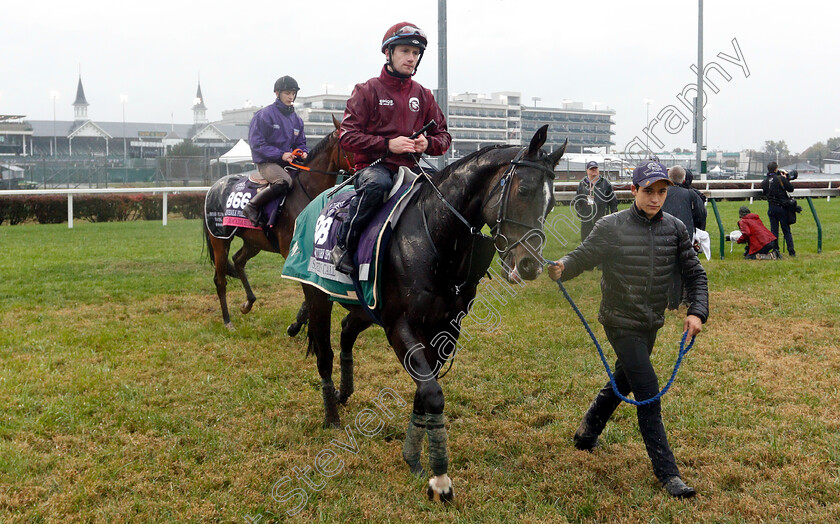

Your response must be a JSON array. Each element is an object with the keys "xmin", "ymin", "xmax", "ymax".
[{"xmin": 0, "ymin": 199, "xmax": 840, "ymax": 523}]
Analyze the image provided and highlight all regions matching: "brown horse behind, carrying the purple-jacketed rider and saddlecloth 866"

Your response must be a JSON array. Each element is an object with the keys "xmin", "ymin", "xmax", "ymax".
[{"xmin": 204, "ymin": 117, "xmax": 353, "ymax": 328}]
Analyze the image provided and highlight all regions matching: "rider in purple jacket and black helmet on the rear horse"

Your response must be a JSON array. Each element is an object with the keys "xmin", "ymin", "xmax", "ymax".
[{"xmin": 242, "ymin": 76, "xmax": 309, "ymax": 226}]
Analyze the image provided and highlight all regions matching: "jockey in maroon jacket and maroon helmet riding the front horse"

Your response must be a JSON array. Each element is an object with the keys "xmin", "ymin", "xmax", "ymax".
[{"xmin": 331, "ymin": 22, "xmax": 452, "ymax": 273}]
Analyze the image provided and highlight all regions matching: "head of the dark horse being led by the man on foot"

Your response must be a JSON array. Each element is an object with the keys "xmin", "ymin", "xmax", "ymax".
[{"xmin": 484, "ymin": 125, "xmax": 568, "ymax": 282}]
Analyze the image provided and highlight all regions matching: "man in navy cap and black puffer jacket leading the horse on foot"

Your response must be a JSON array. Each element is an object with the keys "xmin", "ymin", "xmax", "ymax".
[{"xmin": 548, "ymin": 160, "xmax": 709, "ymax": 498}]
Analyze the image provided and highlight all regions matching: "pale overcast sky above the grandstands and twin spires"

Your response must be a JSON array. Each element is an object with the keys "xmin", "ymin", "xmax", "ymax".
[{"xmin": 0, "ymin": 0, "xmax": 840, "ymax": 152}]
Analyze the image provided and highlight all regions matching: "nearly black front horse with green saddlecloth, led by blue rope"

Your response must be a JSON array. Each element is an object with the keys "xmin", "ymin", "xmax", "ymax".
[{"xmin": 303, "ymin": 126, "xmax": 566, "ymax": 501}]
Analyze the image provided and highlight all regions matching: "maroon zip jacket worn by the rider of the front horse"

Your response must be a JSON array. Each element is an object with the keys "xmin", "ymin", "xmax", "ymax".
[{"xmin": 340, "ymin": 66, "xmax": 452, "ymax": 171}]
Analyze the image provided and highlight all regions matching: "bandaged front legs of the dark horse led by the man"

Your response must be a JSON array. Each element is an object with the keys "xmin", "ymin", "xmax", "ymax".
[{"xmin": 394, "ymin": 326, "xmax": 454, "ymax": 502}]
